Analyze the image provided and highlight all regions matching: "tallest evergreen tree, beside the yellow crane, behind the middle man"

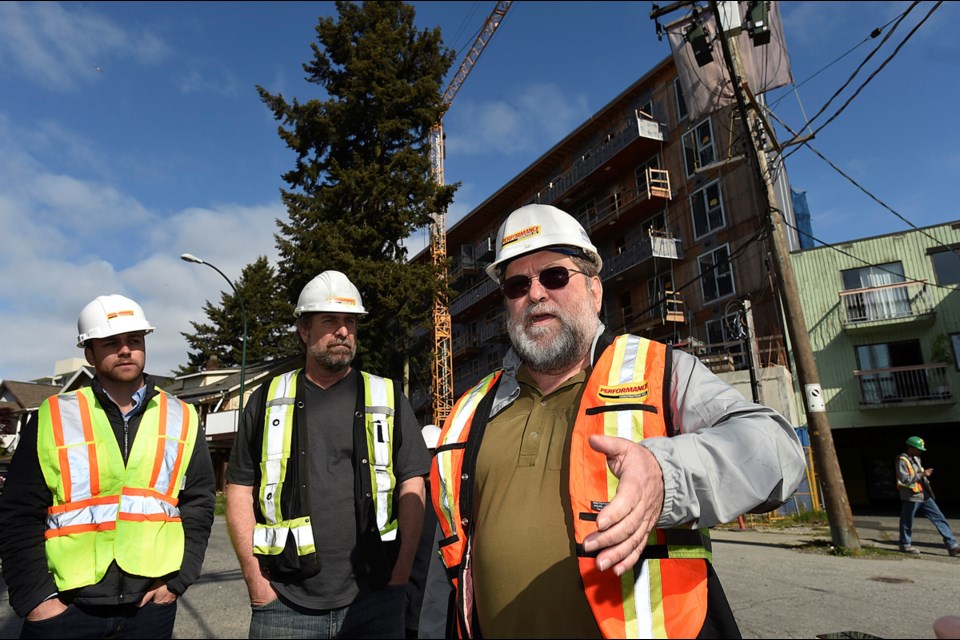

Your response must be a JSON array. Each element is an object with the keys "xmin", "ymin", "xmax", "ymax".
[{"xmin": 257, "ymin": 1, "xmax": 458, "ymax": 377}]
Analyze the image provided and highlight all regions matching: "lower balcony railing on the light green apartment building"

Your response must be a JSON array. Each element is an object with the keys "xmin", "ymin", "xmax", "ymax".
[{"xmin": 853, "ymin": 364, "xmax": 954, "ymax": 408}]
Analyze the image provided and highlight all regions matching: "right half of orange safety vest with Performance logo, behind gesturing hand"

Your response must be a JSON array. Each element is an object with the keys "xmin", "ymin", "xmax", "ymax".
[{"xmin": 570, "ymin": 336, "xmax": 710, "ymax": 638}]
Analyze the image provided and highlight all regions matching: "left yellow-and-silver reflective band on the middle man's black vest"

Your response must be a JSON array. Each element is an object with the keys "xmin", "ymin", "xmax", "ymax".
[{"xmin": 253, "ymin": 369, "xmax": 316, "ymax": 556}]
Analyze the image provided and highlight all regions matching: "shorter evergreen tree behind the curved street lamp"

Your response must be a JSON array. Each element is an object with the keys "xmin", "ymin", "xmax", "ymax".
[{"xmin": 177, "ymin": 256, "xmax": 300, "ymax": 375}]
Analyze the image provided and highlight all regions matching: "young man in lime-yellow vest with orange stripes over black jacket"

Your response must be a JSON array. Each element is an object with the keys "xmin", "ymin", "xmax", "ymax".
[{"xmin": 0, "ymin": 295, "xmax": 215, "ymax": 638}]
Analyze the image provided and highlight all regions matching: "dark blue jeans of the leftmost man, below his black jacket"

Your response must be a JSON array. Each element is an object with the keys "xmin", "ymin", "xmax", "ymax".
[{"xmin": 20, "ymin": 602, "xmax": 177, "ymax": 640}]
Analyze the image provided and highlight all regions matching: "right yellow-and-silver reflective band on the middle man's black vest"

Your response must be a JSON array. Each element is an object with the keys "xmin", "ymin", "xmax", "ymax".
[{"xmin": 361, "ymin": 371, "xmax": 399, "ymax": 541}]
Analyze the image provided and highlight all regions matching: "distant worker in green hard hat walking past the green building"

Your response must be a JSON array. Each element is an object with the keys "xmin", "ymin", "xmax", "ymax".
[{"xmin": 896, "ymin": 436, "xmax": 960, "ymax": 556}]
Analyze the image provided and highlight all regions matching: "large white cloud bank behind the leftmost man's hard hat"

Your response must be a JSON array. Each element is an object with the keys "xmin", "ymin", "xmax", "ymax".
[{"xmin": 0, "ymin": 115, "xmax": 286, "ymax": 380}]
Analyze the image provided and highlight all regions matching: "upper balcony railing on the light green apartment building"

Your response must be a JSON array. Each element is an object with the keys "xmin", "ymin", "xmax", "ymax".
[{"xmin": 840, "ymin": 281, "xmax": 933, "ymax": 328}]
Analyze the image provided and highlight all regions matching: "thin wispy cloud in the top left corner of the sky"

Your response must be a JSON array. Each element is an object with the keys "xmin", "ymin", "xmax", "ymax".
[{"xmin": 0, "ymin": 2, "xmax": 171, "ymax": 91}]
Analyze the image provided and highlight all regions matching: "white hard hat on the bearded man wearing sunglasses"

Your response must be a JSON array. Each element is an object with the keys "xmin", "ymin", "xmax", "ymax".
[{"xmin": 486, "ymin": 204, "xmax": 603, "ymax": 282}]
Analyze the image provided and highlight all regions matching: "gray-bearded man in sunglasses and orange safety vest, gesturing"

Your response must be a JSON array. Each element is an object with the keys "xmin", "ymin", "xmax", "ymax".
[{"xmin": 430, "ymin": 204, "xmax": 805, "ymax": 638}]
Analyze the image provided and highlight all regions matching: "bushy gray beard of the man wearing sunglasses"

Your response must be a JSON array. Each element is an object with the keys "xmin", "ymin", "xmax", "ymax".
[{"xmin": 507, "ymin": 305, "xmax": 595, "ymax": 375}]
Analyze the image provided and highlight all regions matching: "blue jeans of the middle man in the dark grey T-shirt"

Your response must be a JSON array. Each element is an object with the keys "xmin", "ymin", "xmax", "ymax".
[{"xmin": 249, "ymin": 585, "xmax": 407, "ymax": 638}]
